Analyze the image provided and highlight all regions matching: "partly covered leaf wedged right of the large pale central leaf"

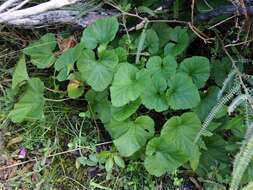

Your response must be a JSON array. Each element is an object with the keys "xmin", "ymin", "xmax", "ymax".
[{"xmin": 142, "ymin": 77, "xmax": 169, "ymax": 112}]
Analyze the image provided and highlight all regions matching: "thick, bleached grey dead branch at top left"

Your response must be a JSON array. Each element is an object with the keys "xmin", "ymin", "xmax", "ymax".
[{"xmin": 0, "ymin": 0, "xmax": 115, "ymax": 29}]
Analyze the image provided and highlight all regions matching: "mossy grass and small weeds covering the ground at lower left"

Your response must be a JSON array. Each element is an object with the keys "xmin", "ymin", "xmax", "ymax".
[{"xmin": 0, "ymin": 78, "xmax": 191, "ymax": 190}]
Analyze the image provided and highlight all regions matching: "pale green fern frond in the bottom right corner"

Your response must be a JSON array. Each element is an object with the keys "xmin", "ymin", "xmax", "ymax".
[{"xmin": 229, "ymin": 131, "xmax": 253, "ymax": 190}]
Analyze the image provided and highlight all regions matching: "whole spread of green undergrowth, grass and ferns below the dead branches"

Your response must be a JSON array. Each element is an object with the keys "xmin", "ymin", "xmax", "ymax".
[{"xmin": 0, "ymin": 1, "xmax": 253, "ymax": 190}]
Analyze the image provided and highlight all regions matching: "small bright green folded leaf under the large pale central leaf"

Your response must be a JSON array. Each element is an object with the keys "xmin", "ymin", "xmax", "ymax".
[{"xmin": 111, "ymin": 98, "xmax": 141, "ymax": 121}]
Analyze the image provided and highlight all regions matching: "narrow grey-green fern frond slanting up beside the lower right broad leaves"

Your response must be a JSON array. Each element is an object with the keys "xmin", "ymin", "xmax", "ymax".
[{"xmin": 194, "ymin": 84, "xmax": 240, "ymax": 143}]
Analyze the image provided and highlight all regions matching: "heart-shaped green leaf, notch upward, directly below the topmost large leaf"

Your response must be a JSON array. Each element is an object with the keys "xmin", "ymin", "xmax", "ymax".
[{"xmin": 77, "ymin": 50, "xmax": 118, "ymax": 91}]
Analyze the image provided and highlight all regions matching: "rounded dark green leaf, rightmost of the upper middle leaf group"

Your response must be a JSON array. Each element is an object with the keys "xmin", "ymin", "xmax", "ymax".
[{"xmin": 179, "ymin": 56, "xmax": 210, "ymax": 88}]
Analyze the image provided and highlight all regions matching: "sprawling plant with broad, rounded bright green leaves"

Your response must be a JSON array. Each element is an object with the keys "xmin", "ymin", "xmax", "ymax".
[{"xmin": 7, "ymin": 17, "xmax": 209, "ymax": 176}]
